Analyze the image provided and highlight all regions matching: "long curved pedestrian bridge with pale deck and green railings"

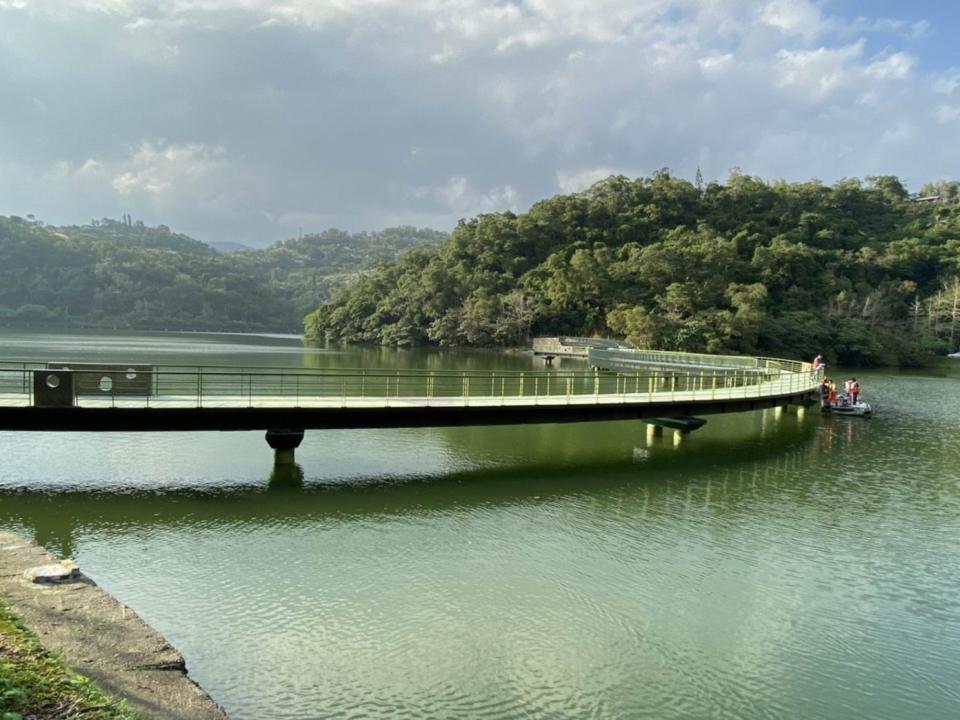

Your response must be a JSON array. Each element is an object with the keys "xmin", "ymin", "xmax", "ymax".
[{"xmin": 0, "ymin": 348, "xmax": 820, "ymax": 430}]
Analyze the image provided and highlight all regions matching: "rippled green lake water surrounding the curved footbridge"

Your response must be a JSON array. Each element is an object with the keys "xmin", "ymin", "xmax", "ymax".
[{"xmin": 0, "ymin": 331, "xmax": 960, "ymax": 720}]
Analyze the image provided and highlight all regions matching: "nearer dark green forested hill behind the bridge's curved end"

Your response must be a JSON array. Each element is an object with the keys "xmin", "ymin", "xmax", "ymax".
[{"xmin": 306, "ymin": 172, "xmax": 960, "ymax": 364}]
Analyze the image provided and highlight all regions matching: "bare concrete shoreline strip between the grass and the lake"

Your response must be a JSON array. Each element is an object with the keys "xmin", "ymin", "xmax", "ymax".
[{"xmin": 0, "ymin": 530, "xmax": 227, "ymax": 720}]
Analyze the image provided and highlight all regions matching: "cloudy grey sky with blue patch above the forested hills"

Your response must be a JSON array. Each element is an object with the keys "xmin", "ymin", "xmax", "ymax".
[{"xmin": 0, "ymin": 0, "xmax": 960, "ymax": 246}]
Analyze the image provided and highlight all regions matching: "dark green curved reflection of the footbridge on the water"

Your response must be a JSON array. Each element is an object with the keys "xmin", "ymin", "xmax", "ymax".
[{"xmin": 0, "ymin": 402, "xmax": 840, "ymax": 557}]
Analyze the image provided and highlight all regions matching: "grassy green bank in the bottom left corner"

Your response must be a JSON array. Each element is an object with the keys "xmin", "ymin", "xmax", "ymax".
[{"xmin": 0, "ymin": 602, "xmax": 139, "ymax": 720}]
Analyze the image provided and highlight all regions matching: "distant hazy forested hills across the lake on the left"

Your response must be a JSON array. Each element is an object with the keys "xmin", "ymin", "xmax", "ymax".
[{"xmin": 0, "ymin": 217, "xmax": 447, "ymax": 332}]
